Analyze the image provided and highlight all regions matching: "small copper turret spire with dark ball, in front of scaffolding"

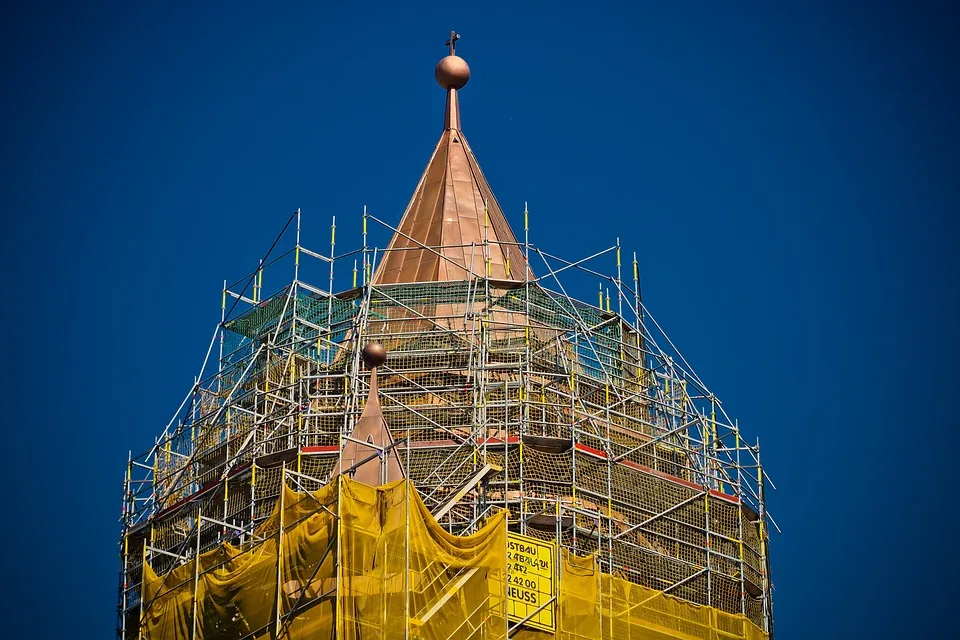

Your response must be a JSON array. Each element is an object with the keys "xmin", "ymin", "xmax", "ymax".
[{"xmin": 333, "ymin": 342, "xmax": 403, "ymax": 487}]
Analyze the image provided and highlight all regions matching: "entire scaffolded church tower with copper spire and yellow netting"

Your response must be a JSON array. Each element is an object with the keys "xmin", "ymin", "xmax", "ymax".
[{"xmin": 118, "ymin": 33, "xmax": 775, "ymax": 640}]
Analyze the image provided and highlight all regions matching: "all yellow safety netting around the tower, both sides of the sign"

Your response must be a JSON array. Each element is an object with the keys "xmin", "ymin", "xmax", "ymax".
[{"xmin": 140, "ymin": 476, "xmax": 767, "ymax": 640}]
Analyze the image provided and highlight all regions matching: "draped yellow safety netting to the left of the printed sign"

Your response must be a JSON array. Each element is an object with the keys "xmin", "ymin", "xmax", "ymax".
[{"xmin": 140, "ymin": 476, "xmax": 507, "ymax": 640}]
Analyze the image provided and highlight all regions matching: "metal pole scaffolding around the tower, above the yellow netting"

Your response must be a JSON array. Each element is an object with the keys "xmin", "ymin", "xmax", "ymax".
[{"xmin": 118, "ymin": 210, "xmax": 776, "ymax": 640}]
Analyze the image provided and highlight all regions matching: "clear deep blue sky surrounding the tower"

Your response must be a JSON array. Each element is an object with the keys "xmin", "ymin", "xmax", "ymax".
[{"xmin": 0, "ymin": 1, "xmax": 960, "ymax": 640}]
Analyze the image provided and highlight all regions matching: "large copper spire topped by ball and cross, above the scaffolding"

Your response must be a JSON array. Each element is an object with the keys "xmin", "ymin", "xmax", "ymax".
[{"xmin": 373, "ymin": 31, "xmax": 527, "ymax": 284}]
